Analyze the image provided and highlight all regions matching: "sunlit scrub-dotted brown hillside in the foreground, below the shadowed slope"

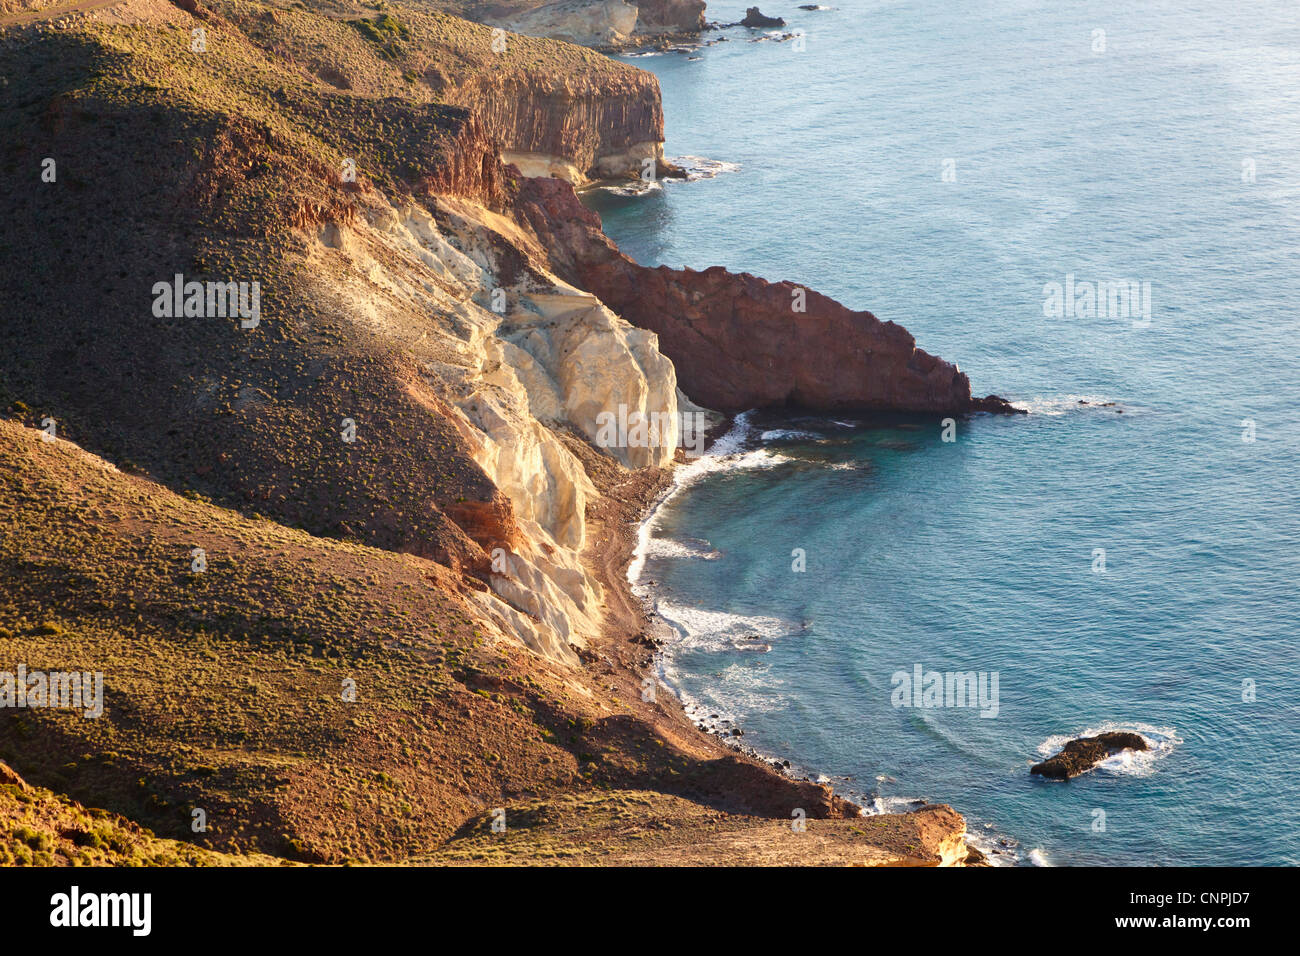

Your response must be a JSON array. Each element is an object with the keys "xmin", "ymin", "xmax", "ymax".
[{"xmin": 0, "ymin": 421, "xmax": 977, "ymax": 862}]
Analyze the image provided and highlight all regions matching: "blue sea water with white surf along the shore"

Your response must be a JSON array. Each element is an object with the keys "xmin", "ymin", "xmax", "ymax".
[{"xmin": 588, "ymin": 0, "xmax": 1300, "ymax": 865}]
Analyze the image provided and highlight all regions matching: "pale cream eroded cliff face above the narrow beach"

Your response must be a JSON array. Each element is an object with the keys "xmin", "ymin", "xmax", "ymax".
[{"xmin": 302, "ymin": 178, "xmax": 677, "ymax": 665}]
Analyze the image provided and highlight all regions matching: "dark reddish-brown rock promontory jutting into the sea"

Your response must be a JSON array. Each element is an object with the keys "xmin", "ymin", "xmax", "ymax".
[{"xmin": 516, "ymin": 179, "xmax": 1011, "ymax": 412}]
